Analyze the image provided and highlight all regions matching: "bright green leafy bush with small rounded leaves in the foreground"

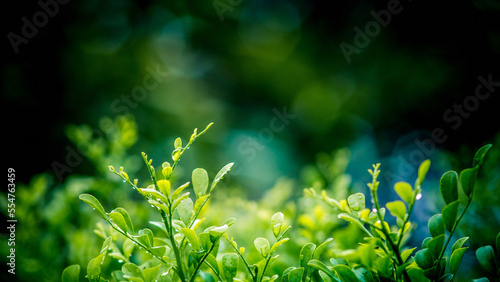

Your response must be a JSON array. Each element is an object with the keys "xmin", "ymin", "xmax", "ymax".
[{"xmin": 62, "ymin": 124, "xmax": 500, "ymax": 281}]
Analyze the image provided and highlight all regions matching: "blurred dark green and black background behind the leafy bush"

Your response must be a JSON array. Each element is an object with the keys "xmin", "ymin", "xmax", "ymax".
[{"xmin": 0, "ymin": 0, "xmax": 500, "ymax": 281}]
